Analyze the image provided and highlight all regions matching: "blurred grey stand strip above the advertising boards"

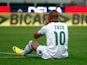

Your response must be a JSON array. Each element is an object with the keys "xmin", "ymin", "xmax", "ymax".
[{"xmin": 0, "ymin": 0, "xmax": 87, "ymax": 7}]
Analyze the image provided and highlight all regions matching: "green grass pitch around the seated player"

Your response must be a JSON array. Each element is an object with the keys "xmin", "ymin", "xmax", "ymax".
[{"xmin": 0, "ymin": 27, "xmax": 87, "ymax": 65}]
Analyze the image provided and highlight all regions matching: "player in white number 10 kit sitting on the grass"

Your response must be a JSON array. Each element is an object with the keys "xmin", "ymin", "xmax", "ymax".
[{"xmin": 13, "ymin": 10, "xmax": 68, "ymax": 59}]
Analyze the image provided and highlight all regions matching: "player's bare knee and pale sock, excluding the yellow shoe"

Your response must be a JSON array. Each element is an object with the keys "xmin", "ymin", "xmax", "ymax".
[{"xmin": 22, "ymin": 41, "xmax": 39, "ymax": 56}]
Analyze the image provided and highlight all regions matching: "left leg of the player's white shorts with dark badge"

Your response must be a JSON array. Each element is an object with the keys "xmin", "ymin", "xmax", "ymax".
[{"xmin": 37, "ymin": 45, "xmax": 51, "ymax": 59}]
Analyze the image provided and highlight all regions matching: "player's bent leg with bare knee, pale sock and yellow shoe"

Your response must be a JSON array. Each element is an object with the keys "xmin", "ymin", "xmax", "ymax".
[{"xmin": 13, "ymin": 40, "xmax": 39, "ymax": 56}]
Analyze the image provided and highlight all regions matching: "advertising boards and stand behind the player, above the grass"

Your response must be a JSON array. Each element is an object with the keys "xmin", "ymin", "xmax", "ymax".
[{"xmin": 0, "ymin": 0, "xmax": 87, "ymax": 26}]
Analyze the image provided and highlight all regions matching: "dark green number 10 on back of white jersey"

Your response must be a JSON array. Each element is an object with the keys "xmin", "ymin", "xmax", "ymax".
[{"xmin": 54, "ymin": 31, "xmax": 65, "ymax": 45}]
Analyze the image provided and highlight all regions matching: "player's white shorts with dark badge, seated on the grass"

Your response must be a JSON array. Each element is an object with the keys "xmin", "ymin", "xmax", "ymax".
[{"xmin": 36, "ymin": 45, "xmax": 68, "ymax": 59}]
